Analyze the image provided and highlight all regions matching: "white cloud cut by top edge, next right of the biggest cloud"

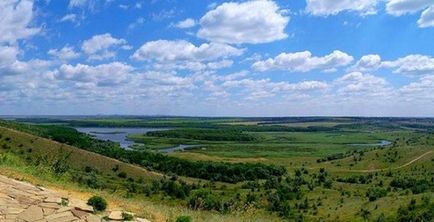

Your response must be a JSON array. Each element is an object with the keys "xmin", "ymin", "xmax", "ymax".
[{"xmin": 306, "ymin": 0, "xmax": 378, "ymax": 16}]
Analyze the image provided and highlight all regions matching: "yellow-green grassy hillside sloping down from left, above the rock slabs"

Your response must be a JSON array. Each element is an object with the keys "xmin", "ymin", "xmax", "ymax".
[{"xmin": 0, "ymin": 127, "xmax": 278, "ymax": 221}]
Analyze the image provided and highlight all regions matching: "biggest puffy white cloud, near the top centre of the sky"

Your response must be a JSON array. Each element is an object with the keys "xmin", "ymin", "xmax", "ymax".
[{"xmin": 197, "ymin": 0, "xmax": 289, "ymax": 44}]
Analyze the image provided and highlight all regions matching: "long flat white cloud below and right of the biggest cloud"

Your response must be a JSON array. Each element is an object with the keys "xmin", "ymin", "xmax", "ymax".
[{"xmin": 252, "ymin": 50, "xmax": 353, "ymax": 72}]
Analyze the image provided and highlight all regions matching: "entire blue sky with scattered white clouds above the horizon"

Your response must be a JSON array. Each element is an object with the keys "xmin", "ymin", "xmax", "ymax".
[{"xmin": 0, "ymin": 0, "xmax": 434, "ymax": 117}]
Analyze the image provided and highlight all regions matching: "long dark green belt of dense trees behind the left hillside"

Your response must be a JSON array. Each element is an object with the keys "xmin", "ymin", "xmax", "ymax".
[{"xmin": 0, "ymin": 122, "xmax": 285, "ymax": 182}]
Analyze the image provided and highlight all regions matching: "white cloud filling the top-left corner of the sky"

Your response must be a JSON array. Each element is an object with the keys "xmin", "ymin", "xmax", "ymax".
[{"xmin": 0, "ymin": 0, "xmax": 40, "ymax": 43}]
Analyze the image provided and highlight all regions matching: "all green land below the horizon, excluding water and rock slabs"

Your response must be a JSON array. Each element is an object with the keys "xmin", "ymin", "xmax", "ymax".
[{"xmin": 0, "ymin": 117, "xmax": 434, "ymax": 221}]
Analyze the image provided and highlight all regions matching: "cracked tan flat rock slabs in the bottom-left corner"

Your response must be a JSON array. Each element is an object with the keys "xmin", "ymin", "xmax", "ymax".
[{"xmin": 0, "ymin": 176, "xmax": 149, "ymax": 222}]
